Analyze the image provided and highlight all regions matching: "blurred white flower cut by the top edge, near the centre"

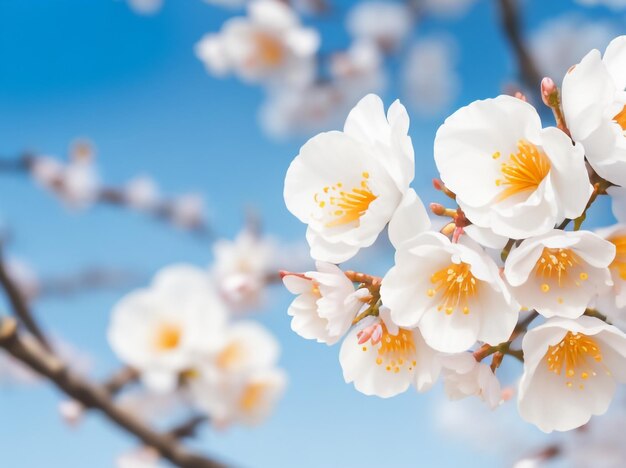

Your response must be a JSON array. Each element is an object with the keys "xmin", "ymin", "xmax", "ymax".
[{"xmin": 346, "ymin": 1, "xmax": 413, "ymax": 49}]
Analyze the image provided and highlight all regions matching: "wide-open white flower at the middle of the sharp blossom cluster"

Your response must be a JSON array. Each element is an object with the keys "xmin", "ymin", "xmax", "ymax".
[{"xmin": 381, "ymin": 232, "xmax": 519, "ymax": 353}]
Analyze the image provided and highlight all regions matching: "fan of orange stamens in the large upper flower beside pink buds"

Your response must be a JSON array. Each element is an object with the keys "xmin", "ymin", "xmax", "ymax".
[{"xmin": 492, "ymin": 140, "xmax": 550, "ymax": 201}]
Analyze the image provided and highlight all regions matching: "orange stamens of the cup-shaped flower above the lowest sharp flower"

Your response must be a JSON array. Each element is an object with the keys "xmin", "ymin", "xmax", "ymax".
[{"xmin": 535, "ymin": 247, "xmax": 589, "ymax": 303}]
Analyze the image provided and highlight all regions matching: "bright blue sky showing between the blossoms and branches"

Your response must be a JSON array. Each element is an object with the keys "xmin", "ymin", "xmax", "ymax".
[{"xmin": 0, "ymin": 0, "xmax": 625, "ymax": 468}]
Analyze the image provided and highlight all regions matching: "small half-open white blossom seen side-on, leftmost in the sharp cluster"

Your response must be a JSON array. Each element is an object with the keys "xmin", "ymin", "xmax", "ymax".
[{"xmin": 283, "ymin": 262, "xmax": 369, "ymax": 345}]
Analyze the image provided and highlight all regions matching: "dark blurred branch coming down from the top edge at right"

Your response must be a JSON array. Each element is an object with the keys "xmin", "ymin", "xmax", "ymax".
[{"xmin": 498, "ymin": 0, "xmax": 541, "ymax": 90}]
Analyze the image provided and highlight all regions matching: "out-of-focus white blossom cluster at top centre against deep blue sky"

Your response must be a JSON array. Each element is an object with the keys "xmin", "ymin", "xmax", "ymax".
[{"xmin": 195, "ymin": 0, "xmax": 474, "ymax": 137}]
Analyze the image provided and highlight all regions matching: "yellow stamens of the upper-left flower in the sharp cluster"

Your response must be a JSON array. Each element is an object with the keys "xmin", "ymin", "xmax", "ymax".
[{"xmin": 313, "ymin": 172, "xmax": 377, "ymax": 227}]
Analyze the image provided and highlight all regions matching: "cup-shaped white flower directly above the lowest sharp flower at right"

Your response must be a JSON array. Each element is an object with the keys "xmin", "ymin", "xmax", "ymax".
[{"xmin": 504, "ymin": 229, "xmax": 615, "ymax": 318}]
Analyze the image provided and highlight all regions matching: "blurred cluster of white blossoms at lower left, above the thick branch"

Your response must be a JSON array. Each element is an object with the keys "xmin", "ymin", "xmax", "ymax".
[{"xmin": 108, "ymin": 231, "xmax": 286, "ymax": 425}]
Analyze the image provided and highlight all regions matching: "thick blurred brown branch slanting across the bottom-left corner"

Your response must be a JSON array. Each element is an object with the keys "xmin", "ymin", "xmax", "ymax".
[{"xmin": 0, "ymin": 317, "xmax": 223, "ymax": 468}]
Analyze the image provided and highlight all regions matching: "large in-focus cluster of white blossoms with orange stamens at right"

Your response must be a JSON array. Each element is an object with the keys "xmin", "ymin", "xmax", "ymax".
[{"xmin": 282, "ymin": 36, "xmax": 626, "ymax": 432}]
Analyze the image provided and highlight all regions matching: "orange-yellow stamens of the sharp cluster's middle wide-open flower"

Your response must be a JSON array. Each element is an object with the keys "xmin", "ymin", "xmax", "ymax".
[{"xmin": 426, "ymin": 262, "xmax": 478, "ymax": 315}]
